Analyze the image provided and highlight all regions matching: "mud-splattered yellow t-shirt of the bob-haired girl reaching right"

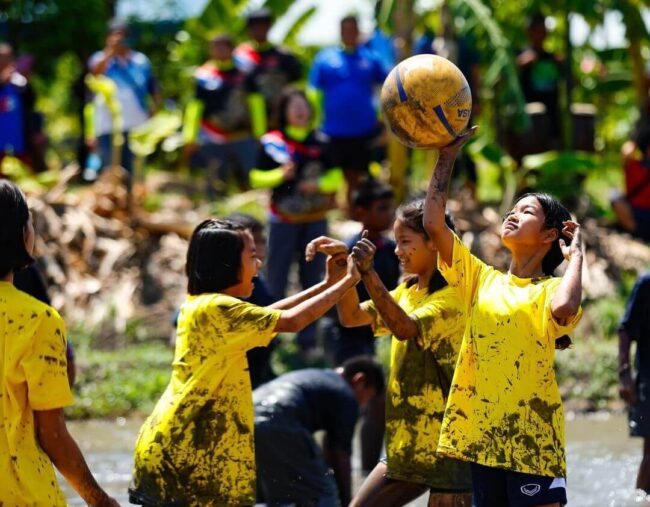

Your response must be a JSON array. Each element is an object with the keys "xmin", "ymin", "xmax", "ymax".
[{"xmin": 133, "ymin": 294, "xmax": 280, "ymax": 506}]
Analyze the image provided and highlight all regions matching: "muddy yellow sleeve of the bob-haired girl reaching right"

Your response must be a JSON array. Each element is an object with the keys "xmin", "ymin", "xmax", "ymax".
[{"xmin": 218, "ymin": 300, "xmax": 282, "ymax": 350}]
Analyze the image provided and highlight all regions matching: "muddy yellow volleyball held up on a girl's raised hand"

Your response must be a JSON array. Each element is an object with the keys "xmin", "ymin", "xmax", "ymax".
[{"xmin": 380, "ymin": 55, "xmax": 472, "ymax": 148}]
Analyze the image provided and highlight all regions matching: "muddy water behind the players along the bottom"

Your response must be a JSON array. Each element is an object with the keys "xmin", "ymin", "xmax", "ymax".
[{"xmin": 62, "ymin": 414, "xmax": 650, "ymax": 507}]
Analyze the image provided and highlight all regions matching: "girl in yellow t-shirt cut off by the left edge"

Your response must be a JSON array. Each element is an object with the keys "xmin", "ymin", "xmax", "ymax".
[{"xmin": 0, "ymin": 180, "xmax": 118, "ymax": 507}]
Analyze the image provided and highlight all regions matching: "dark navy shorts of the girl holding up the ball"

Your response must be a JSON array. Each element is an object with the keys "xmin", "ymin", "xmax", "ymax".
[{"xmin": 471, "ymin": 463, "xmax": 567, "ymax": 507}]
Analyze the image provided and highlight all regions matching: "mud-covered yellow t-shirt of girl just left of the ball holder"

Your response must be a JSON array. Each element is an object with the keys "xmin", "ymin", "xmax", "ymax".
[{"xmin": 363, "ymin": 283, "xmax": 471, "ymax": 490}]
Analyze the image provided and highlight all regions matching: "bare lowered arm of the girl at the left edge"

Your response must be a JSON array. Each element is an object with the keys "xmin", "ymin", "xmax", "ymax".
[{"xmin": 34, "ymin": 408, "xmax": 119, "ymax": 507}]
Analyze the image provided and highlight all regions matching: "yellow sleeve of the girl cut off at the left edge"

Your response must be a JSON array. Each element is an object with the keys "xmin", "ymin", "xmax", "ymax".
[{"xmin": 22, "ymin": 308, "xmax": 73, "ymax": 410}]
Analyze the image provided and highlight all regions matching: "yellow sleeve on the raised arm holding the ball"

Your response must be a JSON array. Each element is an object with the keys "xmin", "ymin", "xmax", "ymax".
[{"xmin": 438, "ymin": 234, "xmax": 487, "ymax": 311}]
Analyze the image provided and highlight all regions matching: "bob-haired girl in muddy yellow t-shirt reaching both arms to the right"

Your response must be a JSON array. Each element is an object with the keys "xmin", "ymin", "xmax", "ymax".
[{"xmin": 129, "ymin": 220, "xmax": 360, "ymax": 506}]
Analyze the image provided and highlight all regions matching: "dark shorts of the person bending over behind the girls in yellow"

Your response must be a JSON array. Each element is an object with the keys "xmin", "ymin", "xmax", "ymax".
[{"xmin": 255, "ymin": 421, "xmax": 340, "ymax": 507}]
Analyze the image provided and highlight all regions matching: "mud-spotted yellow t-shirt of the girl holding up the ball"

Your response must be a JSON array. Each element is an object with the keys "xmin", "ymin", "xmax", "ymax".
[{"xmin": 438, "ymin": 237, "xmax": 582, "ymax": 477}]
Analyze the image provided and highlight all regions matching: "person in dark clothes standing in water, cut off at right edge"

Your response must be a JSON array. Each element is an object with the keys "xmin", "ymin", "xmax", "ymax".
[{"xmin": 618, "ymin": 272, "xmax": 650, "ymax": 494}]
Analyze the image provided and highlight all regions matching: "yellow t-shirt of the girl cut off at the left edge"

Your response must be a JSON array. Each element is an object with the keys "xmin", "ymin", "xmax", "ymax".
[{"xmin": 0, "ymin": 282, "xmax": 72, "ymax": 506}]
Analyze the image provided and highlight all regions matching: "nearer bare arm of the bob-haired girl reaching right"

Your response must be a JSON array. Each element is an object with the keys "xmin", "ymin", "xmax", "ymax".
[{"xmin": 275, "ymin": 257, "xmax": 361, "ymax": 333}]
